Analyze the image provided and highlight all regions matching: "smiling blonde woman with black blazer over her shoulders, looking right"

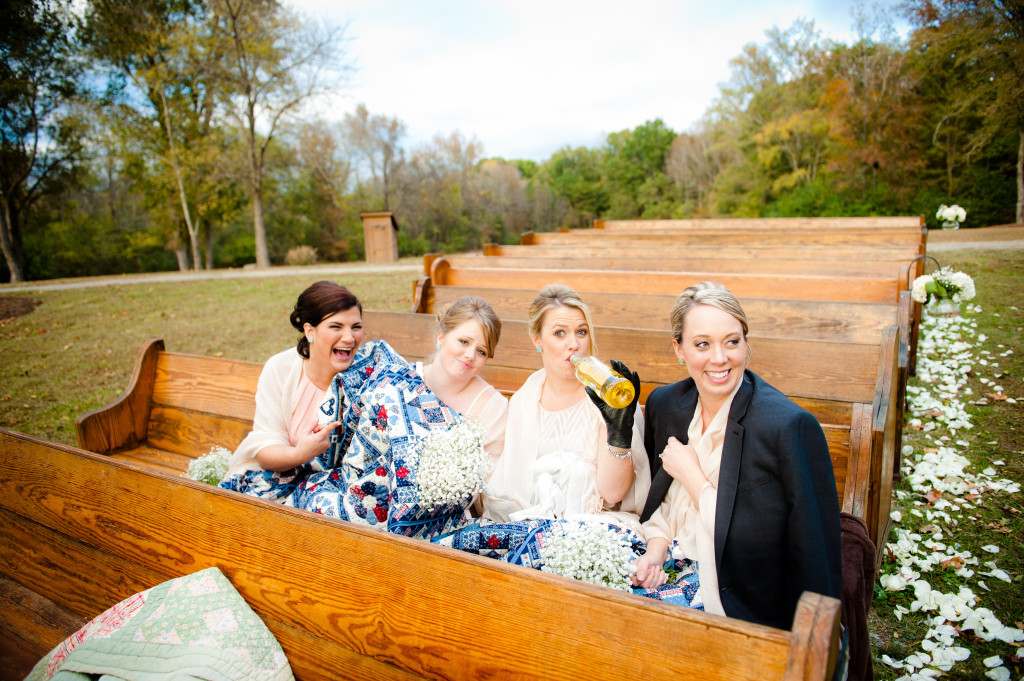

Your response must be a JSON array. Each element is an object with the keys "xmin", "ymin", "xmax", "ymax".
[{"xmin": 634, "ymin": 282, "xmax": 841, "ymax": 629}]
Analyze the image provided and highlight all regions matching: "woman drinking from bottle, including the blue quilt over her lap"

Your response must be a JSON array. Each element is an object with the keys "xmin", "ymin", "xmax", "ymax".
[{"xmin": 437, "ymin": 284, "xmax": 650, "ymax": 589}]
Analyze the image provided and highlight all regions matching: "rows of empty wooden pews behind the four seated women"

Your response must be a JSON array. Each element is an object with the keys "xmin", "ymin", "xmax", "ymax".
[{"xmin": 413, "ymin": 217, "xmax": 927, "ymax": 560}]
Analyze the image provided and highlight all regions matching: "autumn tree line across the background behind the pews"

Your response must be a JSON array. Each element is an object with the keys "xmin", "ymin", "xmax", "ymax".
[{"xmin": 0, "ymin": 0, "xmax": 1024, "ymax": 281}]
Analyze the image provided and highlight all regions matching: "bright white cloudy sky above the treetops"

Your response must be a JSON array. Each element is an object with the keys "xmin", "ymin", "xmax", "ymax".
[{"xmin": 292, "ymin": 0, "xmax": 905, "ymax": 161}]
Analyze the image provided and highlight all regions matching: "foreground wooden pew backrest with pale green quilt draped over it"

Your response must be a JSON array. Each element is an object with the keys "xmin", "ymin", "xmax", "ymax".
[{"xmin": 0, "ymin": 429, "xmax": 839, "ymax": 681}]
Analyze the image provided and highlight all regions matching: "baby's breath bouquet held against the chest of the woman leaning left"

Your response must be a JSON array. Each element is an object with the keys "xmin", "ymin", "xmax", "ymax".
[{"xmin": 416, "ymin": 419, "xmax": 490, "ymax": 506}]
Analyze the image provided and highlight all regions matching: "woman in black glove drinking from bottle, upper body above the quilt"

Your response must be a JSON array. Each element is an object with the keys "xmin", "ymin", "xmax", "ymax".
[{"xmin": 484, "ymin": 284, "xmax": 650, "ymax": 531}]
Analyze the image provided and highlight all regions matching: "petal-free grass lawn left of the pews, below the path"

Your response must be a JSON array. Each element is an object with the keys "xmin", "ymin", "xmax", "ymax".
[{"xmin": 0, "ymin": 271, "xmax": 415, "ymax": 445}]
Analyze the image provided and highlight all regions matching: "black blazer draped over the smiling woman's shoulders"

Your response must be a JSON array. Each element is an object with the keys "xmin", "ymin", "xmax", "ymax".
[{"xmin": 641, "ymin": 371, "xmax": 842, "ymax": 630}]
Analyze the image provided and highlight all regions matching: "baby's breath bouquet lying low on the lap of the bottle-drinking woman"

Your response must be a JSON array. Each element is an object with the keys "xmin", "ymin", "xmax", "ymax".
[{"xmin": 541, "ymin": 520, "xmax": 636, "ymax": 591}]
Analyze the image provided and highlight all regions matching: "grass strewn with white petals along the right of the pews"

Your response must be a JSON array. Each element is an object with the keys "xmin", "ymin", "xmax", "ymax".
[{"xmin": 869, "ymin": 251, "xmax": 1024, "ymax": 680}]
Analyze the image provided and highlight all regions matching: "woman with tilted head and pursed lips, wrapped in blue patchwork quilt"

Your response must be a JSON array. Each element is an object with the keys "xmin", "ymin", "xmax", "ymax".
[{"xmin": 293, "ymin": 297, "xmax": 507, "ymax": 539}]
